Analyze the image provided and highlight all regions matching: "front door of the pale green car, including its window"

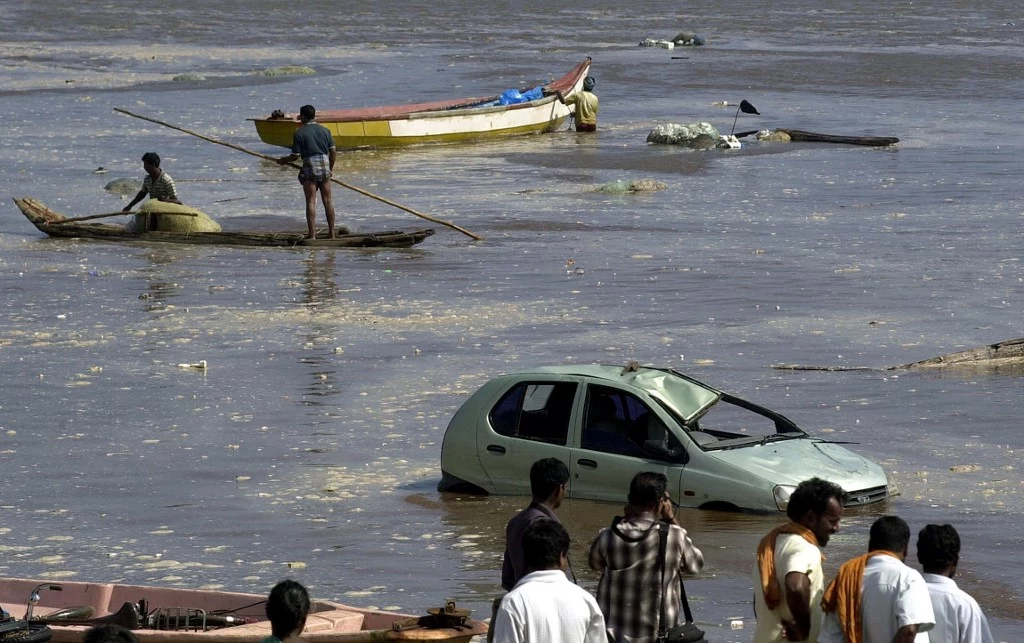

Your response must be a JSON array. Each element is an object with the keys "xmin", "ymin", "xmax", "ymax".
[{"xmin": 569, "ymin": 383, "xmax": 685, "ymax": 502}]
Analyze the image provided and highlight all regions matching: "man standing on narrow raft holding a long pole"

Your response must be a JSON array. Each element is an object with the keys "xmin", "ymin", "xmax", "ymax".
[{"xmin": 278, "ymin": 104, "xmax": 337, "ymax": 239}]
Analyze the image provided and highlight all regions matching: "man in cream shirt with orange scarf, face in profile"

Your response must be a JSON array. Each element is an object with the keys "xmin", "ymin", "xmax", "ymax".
[{"xmin": 754, "ymin": 478, "xmax": 846, "ymax": 643}]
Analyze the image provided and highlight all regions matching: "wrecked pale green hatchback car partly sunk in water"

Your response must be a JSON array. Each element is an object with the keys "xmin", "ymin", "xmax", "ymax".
[{"xmin": 437, "ymin": 362, "xmax": 897, "ymax": 512}]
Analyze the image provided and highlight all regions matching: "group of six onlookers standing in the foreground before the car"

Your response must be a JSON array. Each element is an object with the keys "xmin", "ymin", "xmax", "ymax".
[{"xmin": 488, "ymin": 458, "xmax": 992, "ymax": 643}]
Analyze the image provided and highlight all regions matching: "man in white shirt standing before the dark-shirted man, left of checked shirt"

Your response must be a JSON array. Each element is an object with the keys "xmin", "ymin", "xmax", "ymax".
[{"xmin": 492, "ymin": 519, "xmax": 608, "ymax": 643}]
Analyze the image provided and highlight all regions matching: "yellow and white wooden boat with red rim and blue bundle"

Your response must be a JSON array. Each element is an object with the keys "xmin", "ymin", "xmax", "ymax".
[{"xmin": 250, "ymin": 57, "xmax": 590, "ymax": 148}]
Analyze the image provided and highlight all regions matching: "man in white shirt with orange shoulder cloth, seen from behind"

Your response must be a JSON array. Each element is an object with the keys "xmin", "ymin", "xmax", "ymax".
[{"xmin": 818, "ymin": 516, "xmax": 935, "ymax": 643}]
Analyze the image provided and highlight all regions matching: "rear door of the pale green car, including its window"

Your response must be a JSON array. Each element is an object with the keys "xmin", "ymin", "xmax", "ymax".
[{"xmin": 477, "ymin": 378, "xmax": 580, "ymax": 495}]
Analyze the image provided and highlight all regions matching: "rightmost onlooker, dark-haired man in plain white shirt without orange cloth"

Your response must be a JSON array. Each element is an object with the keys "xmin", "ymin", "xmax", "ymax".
[{"xmin": 918, "ymin": 524, "xmax": 992, "ymax": 643}]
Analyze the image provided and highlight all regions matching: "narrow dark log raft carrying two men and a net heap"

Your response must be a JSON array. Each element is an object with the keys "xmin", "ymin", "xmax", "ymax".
[{"xmin": 14, "ymin": 197, "xmax": 434, "ymax": 248}]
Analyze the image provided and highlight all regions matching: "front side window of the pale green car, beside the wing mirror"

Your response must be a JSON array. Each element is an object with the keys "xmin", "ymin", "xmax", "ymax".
[{"xmin": 581, "ymin": 386, "xmax": 683, "ymax": 462}]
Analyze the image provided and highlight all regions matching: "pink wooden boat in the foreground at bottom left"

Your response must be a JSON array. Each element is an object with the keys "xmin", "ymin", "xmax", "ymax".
[{"xmin": 0, "ymin": 578, "xmax": 487, "ymax": 643}]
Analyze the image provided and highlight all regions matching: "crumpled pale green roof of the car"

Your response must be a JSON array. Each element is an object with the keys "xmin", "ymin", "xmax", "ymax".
[{"xmin": 507, "ymin": 363, "xmax": 722, "ymax": 422}]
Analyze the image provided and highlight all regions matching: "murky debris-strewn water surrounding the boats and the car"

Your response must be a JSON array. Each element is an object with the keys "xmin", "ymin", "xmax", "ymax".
[{"xmin": 0, "ymin": 0, "xmax": 1024, "ymax": 641}]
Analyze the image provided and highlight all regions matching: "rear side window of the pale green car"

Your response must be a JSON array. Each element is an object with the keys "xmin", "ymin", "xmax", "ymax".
[{"xmin": 489, "ymin": 382, "xmax": 577, "ymax": 445}]
